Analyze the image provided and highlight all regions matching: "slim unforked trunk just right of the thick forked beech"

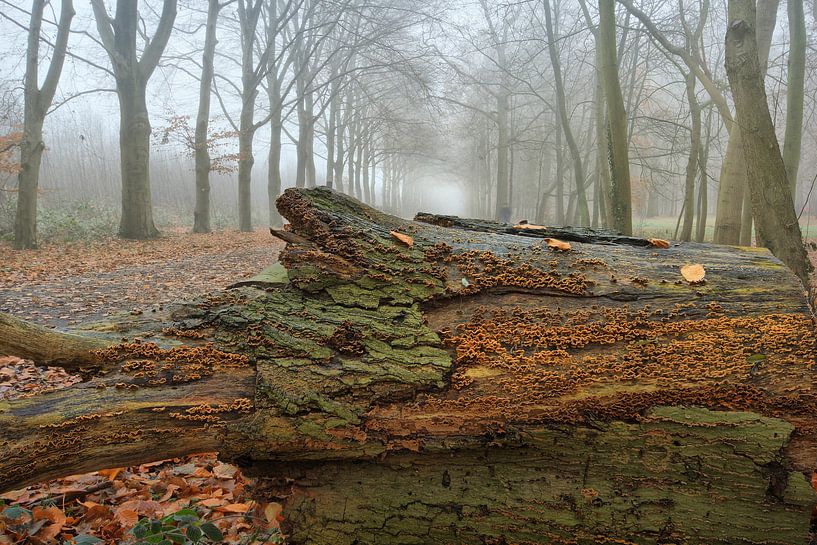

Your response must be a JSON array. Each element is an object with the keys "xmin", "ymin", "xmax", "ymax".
[{"xmin": 193, "ymin": 0, "xmax": 221, "ymax": 233}]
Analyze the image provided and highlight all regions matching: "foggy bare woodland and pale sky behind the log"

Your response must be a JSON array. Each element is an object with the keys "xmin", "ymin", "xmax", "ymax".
[{"xmin": 0, "ymin": 0, "xmax": 817, "ymax": 246}]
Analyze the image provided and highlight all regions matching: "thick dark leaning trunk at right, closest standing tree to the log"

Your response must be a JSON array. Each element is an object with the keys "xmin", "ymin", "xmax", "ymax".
[{"xmin": 726, "ymin": 0, "xmax": 812, "ymax": 285}]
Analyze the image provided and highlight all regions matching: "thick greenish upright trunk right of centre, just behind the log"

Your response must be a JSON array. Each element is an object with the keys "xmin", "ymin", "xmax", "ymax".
[{"xmin": 599, "ymin": 0, "xmax": 633, "ymax": 235}]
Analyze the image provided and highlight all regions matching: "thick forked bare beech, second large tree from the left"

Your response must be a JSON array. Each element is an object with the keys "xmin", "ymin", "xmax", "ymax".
[{"xmin": 91, "ymin": 0, "xmax": 177, "ymax": 239}]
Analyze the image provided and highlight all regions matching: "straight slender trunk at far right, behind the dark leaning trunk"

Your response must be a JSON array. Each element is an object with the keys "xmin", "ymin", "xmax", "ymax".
[{"xmin": 783, "ymin": 0, "xmax": 807, "ymax": 199}]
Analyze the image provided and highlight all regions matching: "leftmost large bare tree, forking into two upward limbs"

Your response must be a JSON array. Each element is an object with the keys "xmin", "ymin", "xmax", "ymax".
[{"xmin": 14, "ymin": 0, "xmax": 74, "ymax": 249}]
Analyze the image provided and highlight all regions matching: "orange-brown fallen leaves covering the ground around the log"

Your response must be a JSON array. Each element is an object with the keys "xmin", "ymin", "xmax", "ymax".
[{"xmin": 0, "ymin": 227, "xmax": 282, "ymax": 545}]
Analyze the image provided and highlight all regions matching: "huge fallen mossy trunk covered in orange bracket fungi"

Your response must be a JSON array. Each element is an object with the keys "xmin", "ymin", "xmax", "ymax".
[{"xmin": 0, "ymin": 189, "xmax": 817, "ymax": 545}]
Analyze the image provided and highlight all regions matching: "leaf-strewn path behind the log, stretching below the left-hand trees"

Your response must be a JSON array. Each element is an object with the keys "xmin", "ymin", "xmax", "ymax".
[{"xmin": 0, "ymin": 226, "xmax": 283, "ymax": 327}]
